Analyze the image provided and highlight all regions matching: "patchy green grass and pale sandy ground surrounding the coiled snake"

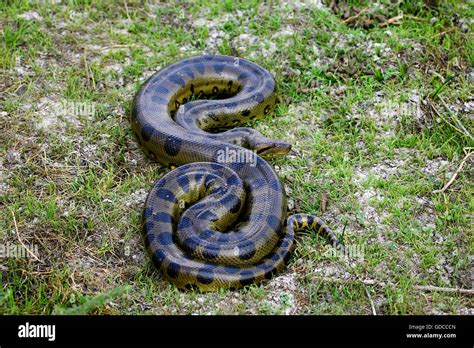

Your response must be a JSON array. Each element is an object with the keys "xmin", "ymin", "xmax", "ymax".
[{"xmin": 0, "ymin": 0, "xmax": 474, "ymax": 314}]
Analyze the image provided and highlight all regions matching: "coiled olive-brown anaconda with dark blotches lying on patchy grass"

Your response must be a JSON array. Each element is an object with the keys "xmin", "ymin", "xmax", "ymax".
[{"xmin": 131, "ymin": 55, "xmax": 339, "ymax": 291}]
